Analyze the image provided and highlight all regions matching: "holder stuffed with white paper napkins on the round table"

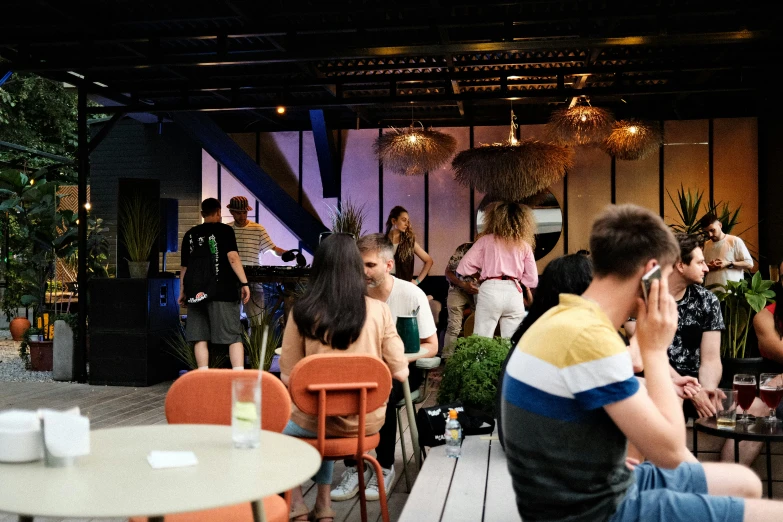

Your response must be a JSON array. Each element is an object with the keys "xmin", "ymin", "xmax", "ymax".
[{"xmin": 38, "ymin": 408, "xmax": 90, "ymax": 468}]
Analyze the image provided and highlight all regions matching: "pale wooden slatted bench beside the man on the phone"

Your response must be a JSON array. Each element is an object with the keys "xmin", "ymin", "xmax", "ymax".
[{"xmin": 399, "ymin": 435, "xmax": 522, "ymax": 522}]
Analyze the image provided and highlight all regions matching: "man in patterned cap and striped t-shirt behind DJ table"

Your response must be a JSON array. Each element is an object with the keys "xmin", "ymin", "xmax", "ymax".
[{"xmin": 226, "ymin": 196, "xmax": 285, "ymax": 320}]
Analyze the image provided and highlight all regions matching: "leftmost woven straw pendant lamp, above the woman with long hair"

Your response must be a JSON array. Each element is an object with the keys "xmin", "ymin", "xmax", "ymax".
[{"xmin": 374, "ymin": 125, "xmax": 457, "ymax": 176}]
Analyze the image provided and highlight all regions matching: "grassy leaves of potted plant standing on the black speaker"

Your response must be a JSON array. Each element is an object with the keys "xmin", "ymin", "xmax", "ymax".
[{"xmin": 118, "ymin": 194, "xmax": 160, "ymax": 262}]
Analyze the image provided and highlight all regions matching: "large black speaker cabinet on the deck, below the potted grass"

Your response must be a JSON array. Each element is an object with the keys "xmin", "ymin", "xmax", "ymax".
[{"xmin": 89, "ymin": 278, "xmax": 180, "ymax": 386}]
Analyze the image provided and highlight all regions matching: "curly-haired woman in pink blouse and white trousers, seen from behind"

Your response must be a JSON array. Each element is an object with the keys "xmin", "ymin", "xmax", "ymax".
[{"xmin": 457, "ymin": 202, "xmax": 538, "ymax": 338}]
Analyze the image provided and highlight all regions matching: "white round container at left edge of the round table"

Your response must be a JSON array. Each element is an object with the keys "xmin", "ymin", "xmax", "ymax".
[{"xmin": 0, "ymin": 409, "xmax": 44, "ymax": 462}]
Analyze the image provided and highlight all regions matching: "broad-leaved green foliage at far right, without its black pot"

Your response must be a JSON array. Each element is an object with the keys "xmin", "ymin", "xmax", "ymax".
[{"xmin": 708, "ymin": 272, "xmax": 775, "ymax": 358}]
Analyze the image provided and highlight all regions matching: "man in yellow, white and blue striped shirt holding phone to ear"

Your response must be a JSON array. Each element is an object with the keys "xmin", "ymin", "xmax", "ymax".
[{"xmin": 501, "ymin": 205, "xmax": 783, "ymax": 522}]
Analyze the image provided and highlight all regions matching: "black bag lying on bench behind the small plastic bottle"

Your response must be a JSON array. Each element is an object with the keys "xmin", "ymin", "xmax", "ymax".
[{"xmin": 416, "ymin": 401, "xmax": 495, "ymax": 447}]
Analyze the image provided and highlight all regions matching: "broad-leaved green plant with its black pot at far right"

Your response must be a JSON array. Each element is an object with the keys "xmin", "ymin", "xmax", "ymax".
[{"xmin": 708, "ymin": 272, "xmax": 775, "ymax": 387}]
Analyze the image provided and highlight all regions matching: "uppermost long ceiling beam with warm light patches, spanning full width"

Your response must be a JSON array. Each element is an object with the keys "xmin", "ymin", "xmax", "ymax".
[{"xmin": 0, "ymin": 30, "xmax": 775, "ymax": 73}]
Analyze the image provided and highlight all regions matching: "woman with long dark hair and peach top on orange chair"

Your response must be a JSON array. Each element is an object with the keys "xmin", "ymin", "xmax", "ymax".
[{"xmin": 280, "ymin": 234, "xmax": 408, "ymax": 521}]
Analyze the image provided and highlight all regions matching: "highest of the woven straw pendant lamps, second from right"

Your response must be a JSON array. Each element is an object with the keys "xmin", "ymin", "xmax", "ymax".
[{"xmin": 547, "ymin": 97, "xmax": 614, "ymax": 147}]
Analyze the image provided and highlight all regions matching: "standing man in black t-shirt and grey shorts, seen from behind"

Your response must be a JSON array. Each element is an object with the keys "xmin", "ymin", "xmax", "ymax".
[{"xmin": 179, "ymin": 198, "xmax": 250, "ymax": 370}]
